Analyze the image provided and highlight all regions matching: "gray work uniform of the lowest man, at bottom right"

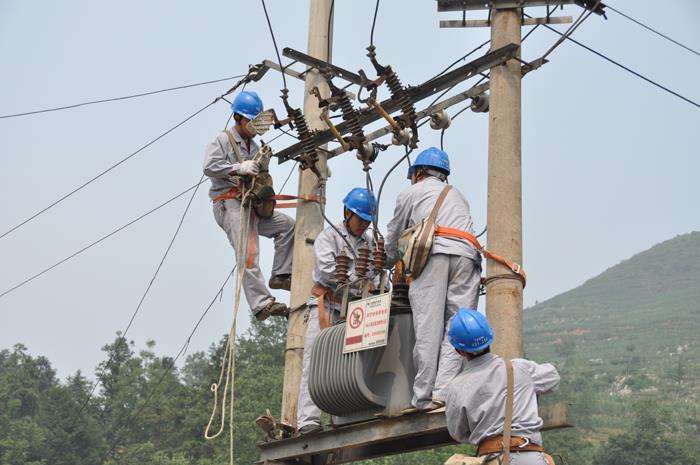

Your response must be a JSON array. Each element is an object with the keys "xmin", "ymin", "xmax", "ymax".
[{"xmin": 445, "ymin": 353, "xmax": 560, "ymax": 465}]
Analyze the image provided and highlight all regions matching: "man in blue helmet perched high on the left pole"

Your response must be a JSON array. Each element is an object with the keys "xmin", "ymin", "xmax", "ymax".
[{"xmin": 204, "ymin": 91, "xmax": 294, "ymax": 320}]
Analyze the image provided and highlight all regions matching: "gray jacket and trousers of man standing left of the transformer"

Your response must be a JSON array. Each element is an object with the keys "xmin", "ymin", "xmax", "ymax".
[{"xmin": 297, "ymin": 223, "xmax": 372, "ymax": 428}]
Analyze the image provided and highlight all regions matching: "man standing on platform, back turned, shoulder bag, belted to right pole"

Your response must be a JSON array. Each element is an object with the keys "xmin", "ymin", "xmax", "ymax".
[{"xmin": 386, "ymin": 147, "xmax": 481, "ymax": 413}]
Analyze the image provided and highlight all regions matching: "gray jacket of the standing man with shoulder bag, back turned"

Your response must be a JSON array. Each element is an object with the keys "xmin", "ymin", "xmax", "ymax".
[{"xmin": 386, "ymin": 176, "xmax": 478, "ymax": 266}]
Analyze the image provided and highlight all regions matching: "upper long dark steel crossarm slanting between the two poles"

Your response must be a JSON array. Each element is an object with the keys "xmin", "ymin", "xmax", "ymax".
[{"xmin": 275, "ymin": 44, "xmax": 519, "ymax": 163}]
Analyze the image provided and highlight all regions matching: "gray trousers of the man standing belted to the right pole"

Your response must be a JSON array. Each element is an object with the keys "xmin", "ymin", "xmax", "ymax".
[{"xmin": 408, "ymin": 254, "xmax": 481, "ymax": 409}]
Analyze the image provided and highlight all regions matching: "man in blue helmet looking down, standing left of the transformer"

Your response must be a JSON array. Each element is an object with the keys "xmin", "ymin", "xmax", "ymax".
[{"xmin": 297, "ymin": 187, "xmax": 377, "ymax": 435}]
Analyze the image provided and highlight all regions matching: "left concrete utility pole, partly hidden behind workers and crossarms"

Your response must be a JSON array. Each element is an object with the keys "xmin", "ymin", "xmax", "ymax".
[{"xmin": 281, "ymin": 0, "xmax": 333, "ymax": 426}]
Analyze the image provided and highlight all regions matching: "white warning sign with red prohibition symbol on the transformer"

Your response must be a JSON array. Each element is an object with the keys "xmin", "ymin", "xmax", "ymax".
[{"xmin": 343, "ymin": 292, "xmax": 391, "ymax": 354}]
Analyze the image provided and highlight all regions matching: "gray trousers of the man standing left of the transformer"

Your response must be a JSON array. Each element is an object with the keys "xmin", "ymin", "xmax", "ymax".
[{"xmin": 297, "ymin": 298, "xmax": 340, "ymax": 428}]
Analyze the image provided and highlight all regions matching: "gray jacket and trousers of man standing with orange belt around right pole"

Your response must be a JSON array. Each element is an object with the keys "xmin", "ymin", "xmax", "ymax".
[{"xmin": 386, "ymin": 176, "xmax": 481, "ymax": 409}]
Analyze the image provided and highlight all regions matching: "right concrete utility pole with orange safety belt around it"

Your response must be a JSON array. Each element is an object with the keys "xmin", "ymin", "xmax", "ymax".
[{"xmin": 486, "ymin": 8, "xmax": 523, "ymax": 358}]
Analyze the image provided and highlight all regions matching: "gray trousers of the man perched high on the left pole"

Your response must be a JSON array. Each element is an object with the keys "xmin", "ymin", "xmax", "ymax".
[{"xmin": 213, "ymin": 199, "xmax": 294, "ymax": 314}]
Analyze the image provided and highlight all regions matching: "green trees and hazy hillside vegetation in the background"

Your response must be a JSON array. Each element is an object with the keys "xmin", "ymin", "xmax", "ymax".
[{"xmin": 0, "ymin": 233, "xmax": 700, "ymax": 465}]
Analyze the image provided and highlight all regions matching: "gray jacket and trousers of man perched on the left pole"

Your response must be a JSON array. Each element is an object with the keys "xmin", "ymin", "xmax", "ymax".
[{"xmin": 204, "ymin": 129, "xmax": 294, "ymax": 314}]
